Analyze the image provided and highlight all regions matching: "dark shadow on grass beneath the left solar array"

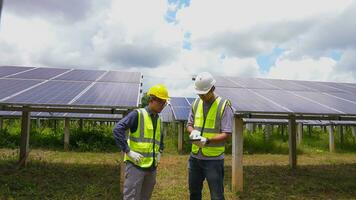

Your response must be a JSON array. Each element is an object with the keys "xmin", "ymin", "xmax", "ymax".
[{"xmin": 0, "ymin": 160, "xmax": 120, "ymax": 200}]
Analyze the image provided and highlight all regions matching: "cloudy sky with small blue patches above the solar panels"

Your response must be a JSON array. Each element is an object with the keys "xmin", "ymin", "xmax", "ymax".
[{"xmin": 0, "ymin": 0, "xmax": 356, "ymax": 97}]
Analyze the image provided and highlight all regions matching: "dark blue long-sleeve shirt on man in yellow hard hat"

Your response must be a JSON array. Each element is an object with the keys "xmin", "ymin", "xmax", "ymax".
[{"xmin": 113, "ymin": 106, "xmax": 164, "ymax": 153}]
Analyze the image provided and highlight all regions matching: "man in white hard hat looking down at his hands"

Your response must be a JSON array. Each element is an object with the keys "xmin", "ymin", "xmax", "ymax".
[{"xmin": 187, "ymin": 72, "xmax": 233, "ymax": 200}]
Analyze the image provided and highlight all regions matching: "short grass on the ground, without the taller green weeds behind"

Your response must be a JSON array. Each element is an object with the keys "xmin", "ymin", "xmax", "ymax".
[{"xmin": 0, "ymin": 149, "xmax": 356, "ymax": 200}]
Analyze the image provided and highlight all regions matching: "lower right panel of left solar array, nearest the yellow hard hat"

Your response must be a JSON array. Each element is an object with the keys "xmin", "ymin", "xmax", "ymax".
[{"xmin": 74, "ymin": 82, "xmax": 139, "ymax": 107}]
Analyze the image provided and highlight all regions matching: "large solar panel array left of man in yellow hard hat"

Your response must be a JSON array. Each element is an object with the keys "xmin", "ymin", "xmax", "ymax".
[{"xmin": 0, "ymin": 66, "xmax": 142, "ymax": 108}]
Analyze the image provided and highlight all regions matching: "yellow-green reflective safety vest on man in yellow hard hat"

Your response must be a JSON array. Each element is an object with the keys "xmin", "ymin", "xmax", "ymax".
[{"xmin": 124, "ymin": 108, "xmax": 161, "ymax": 168}]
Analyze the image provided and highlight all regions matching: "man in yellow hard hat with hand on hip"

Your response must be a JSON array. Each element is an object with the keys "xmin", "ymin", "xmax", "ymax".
[{"xmin": 113, "ymin": 84, "xmax": 169, "ymax": 200}]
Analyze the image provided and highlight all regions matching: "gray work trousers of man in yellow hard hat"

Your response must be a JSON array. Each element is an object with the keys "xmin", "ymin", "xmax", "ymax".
[{"xmin": 124, "ymin": 162, "xmax": 157, "ymax": 200}]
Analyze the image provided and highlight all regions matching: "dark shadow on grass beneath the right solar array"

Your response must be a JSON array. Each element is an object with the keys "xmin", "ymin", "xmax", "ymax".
[{"xmin": 225, "ymin": 163, "xmax": 356, "ymax": 199}]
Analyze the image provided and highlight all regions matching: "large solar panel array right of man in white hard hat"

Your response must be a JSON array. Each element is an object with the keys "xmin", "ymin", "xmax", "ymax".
[{"xmin": 216, "ymin": 77, "xmax": 356, "ymax": 115}]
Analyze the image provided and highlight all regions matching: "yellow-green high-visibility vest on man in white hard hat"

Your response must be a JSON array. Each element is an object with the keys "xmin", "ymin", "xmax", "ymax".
[{"xmin": 192, "ymin": 97, "xmax": 230, "ymax": 157}]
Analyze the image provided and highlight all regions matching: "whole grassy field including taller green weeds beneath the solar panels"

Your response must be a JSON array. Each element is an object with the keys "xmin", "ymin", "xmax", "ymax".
[{"xmin": 0, "ymin": 121, "xmax": 356, "ymax": 200}]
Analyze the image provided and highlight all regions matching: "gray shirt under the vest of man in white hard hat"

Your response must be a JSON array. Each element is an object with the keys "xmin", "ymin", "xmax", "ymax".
[{"xmin": 187, "ymin": 97, "xmax": 234, "ymax": 160}]
